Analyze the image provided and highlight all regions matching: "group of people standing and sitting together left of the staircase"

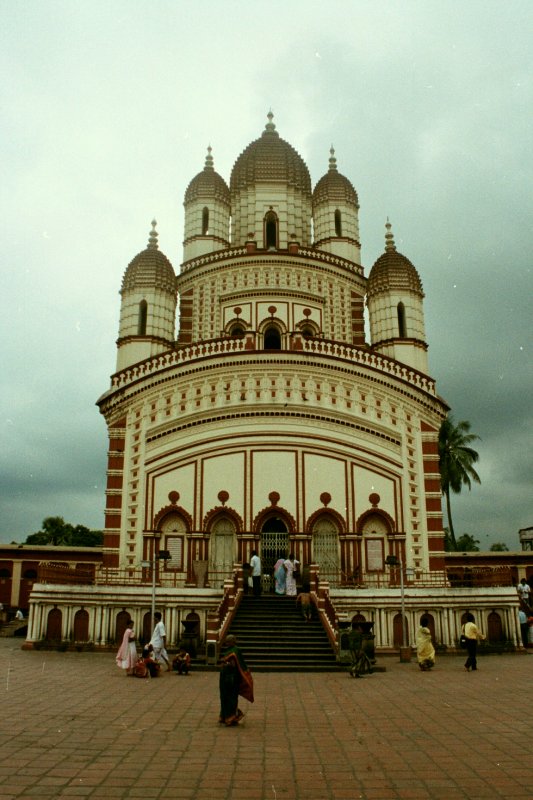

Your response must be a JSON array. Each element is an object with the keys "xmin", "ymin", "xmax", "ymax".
[{"xmin": 116, "ymin": 611, "xmax": 191, "ymax": 678}]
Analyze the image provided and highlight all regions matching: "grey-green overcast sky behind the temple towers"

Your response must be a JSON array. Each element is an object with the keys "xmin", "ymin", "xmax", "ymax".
[{"xmin": 0, "ymin": 0, "xmax": 533, "ymax": 550}]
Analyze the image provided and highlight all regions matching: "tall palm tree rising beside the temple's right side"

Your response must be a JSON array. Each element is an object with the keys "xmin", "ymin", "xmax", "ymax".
[{"xmin": 439, "ymin": 415, "xmax": 481, "ymax": 550}]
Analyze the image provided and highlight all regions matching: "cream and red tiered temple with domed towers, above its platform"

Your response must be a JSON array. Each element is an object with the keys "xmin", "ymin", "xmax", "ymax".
[{"xmin": 98, "ymin": 114, "xmax": 447, "ymax": 586}]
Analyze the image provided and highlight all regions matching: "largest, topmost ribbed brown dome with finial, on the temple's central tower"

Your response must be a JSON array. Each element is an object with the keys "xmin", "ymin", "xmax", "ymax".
[{"xmin": 230, "ymin": 112, "xmax": 311, "ymax": 196}]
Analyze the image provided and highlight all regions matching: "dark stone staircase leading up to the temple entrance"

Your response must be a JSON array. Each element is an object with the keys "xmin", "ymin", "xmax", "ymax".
[{"xmin": 229, "ymin": 594, "xmax": 340, "ymax": 672}]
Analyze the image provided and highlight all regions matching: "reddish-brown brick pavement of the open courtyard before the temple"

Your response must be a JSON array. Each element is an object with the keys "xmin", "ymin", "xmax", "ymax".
[{"xmin": 0, "ymin": 639, "xmax": 533, "ymax": 800}]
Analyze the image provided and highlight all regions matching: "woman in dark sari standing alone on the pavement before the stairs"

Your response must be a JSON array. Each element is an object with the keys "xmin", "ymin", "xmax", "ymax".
[{"xmin": 218, "ymin": 635, "xmax": 254, "ymax": 726}]
